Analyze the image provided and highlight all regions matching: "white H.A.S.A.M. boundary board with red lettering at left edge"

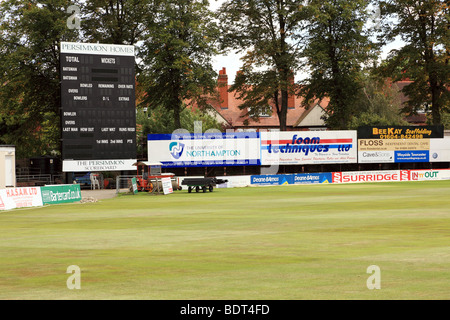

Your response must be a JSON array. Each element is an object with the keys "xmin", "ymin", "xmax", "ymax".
[{"xmin": 0, "ymin": 187, "xmax": 42, "ymax": 210}]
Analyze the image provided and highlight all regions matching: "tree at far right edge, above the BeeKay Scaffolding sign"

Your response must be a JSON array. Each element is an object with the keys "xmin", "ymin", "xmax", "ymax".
[{"xmin": 378, "ymin": 0, "xmax": 450, "ymax": 125}]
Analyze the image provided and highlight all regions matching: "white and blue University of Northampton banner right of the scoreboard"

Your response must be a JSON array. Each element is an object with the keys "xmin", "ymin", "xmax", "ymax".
[{"xmin": 147, "ymin": 132, "xmax": 261, "ymax": 168}]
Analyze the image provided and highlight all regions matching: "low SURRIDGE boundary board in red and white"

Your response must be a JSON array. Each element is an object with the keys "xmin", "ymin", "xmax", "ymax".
[{"xmin": 333, "ymin": 170, "xmax": 407, "ymax": 183}]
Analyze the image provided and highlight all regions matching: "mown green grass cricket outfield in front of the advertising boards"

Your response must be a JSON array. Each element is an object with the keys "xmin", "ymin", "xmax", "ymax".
[{"xmin": 0, "ymin": 181, "xmax": 450, "ymax": 300}]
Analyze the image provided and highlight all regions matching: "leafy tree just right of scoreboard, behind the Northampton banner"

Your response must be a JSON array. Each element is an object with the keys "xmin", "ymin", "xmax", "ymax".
[{"xmin": 138, "ymin": 0, "xmax": 217, "ymax": 128}]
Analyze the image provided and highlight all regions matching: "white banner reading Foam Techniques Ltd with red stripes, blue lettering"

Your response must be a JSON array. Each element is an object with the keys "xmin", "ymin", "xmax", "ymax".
[{"xmin": 261, "ymin": 130, "xmax": 357, "ymax": 165}]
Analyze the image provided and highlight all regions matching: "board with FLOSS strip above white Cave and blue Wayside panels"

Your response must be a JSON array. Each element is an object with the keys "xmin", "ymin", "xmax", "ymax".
[{"xmin": 358, "ymin": 139, "xmax": 431, "ymax": 163}]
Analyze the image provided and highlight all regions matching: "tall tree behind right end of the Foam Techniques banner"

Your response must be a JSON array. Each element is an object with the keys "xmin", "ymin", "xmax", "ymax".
[{"xmin": 300, "ymin": 0, "xmax": 376, "ymax": 129}]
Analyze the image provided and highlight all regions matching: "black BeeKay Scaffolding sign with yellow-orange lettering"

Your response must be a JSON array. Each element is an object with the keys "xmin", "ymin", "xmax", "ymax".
[{"xmin": 358, "ymin": 125, "xmax": 444, "ymax": 139}]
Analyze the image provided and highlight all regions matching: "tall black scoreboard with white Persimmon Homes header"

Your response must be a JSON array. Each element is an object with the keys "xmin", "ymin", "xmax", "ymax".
[{"xmin": 60, "ymin": 42, "xmax": 136, "ymax": 172}]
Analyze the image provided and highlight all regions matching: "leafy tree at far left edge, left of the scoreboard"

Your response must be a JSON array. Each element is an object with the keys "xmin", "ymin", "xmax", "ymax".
[{"xmin": 0, "ymin": 0, "xmax": 77, "ymax": 157}]
